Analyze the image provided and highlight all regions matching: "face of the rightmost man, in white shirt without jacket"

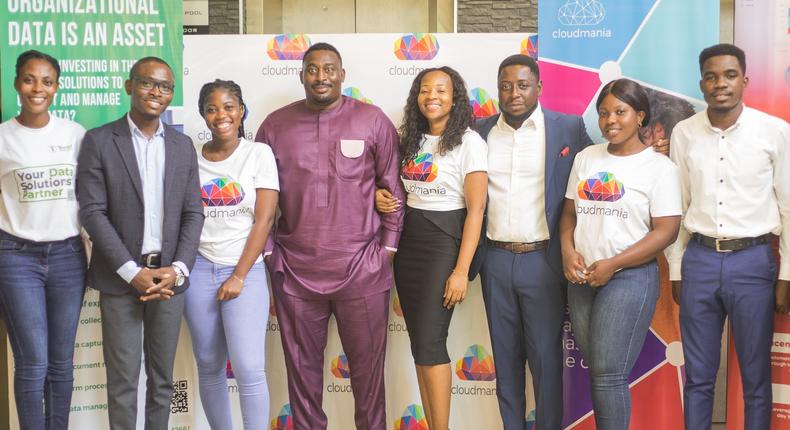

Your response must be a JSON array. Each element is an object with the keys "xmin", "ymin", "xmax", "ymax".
[{"xmin": 699, "ymin": 55, "xmax": 749, "ymax": 114}]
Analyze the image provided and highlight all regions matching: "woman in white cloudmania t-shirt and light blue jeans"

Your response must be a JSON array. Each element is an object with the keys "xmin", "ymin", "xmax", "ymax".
[{"xmin": 184, "ymin": 79, "xmax": 279, "ymax": 429}]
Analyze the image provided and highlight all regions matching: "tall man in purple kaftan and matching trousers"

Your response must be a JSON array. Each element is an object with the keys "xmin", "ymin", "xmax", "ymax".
[{"xmin": 256, "ymin": 43, "xmax": 405, "ymax": 430}]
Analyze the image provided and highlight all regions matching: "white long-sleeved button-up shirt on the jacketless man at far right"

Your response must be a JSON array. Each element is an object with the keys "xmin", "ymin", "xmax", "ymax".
[{"xmin": 667, "ymin": 107, "xmax": 790, "ymax": 280}]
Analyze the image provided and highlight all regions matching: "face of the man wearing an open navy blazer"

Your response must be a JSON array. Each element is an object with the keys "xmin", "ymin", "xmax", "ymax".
[{"xmin": 497, "ymin": 64, "xmax": 543, "ymax": 120}]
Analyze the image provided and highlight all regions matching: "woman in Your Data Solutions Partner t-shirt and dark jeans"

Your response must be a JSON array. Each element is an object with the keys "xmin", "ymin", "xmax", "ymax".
[{"xmin": 0, "ymin": 51, "xmax": 86, "ymax": 429}]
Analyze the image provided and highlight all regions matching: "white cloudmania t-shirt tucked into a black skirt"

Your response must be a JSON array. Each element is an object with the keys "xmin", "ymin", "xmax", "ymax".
[{"xmin": 400, "ymin": 129, "xmax": 488, "ymax": 211}]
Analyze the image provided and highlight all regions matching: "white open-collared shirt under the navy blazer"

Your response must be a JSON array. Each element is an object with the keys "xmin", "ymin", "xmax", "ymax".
[{"xmin": 487, "ymin": 105, "xmax": 549, "ymax": 242}]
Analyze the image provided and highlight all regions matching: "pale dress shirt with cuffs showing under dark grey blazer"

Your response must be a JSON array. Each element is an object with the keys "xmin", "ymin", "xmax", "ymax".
[{"xmin": 117, "ymin": 114, "xmax": 189, "ymax": 283}]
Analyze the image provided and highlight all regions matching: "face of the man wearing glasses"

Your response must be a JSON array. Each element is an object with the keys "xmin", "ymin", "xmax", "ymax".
[{"xmin": 126, "ymin": 61, "xmax": 174, "ymax": 121}]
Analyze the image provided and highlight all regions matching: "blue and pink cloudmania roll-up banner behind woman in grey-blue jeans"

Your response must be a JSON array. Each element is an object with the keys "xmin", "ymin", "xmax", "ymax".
[{"xmin": 538, "ymin": 0, "xmax": 719, "ymax": 430}]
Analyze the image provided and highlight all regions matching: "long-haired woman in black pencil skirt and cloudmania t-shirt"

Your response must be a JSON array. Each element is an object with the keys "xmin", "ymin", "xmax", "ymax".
[{"xmin": 377, "ymin": 67, "xmax": 488, "ymax": 430}]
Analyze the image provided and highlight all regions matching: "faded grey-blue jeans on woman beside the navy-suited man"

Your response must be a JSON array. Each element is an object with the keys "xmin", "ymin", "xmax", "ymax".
[{"xmin": 568, "ymin": 261, "xmax": 659, "ymax": 430}]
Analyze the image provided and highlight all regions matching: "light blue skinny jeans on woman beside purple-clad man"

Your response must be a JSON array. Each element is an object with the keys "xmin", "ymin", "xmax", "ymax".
[{"xmin": 184, "ymin": 255, "xmax": 269, "ymax": 429}]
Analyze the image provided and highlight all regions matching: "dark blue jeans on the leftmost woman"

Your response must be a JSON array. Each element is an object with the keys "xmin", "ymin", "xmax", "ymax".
[{"xmin": 0, "ymin": 231, "xmax": 86, "ymax": 430}]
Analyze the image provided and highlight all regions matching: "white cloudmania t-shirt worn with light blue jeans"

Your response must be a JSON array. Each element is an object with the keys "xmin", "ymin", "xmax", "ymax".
[{"xmin": 197, "ymin": 139, "xmax": 280, "ymax": 266}]
